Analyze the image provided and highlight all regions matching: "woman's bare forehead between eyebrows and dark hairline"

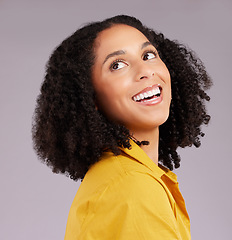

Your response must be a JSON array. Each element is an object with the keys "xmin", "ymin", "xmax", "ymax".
[{"xmin": 95, "ymin": 24, "xmax": 148, "ymax": 56}]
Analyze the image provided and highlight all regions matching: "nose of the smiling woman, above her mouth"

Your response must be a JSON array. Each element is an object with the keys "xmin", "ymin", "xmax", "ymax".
[{"xmin": 135, "ymin": 61, "xmax": 155, "ymax": 81}]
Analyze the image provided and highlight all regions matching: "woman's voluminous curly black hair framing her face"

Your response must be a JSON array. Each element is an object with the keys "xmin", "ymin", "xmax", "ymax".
[{"xmin": 32, "ymin": 15, "xmax": 212, "ymax": 180}]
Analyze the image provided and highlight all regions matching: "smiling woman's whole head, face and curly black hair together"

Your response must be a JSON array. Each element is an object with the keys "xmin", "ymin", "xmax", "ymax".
[{"xmin": 33, "ymin": 16, "xmax": 211, "ymax": 179}]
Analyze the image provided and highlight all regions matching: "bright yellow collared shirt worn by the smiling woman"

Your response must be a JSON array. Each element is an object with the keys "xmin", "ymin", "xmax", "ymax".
[{"xmin": 65, "ymin": 141, "xmax": 191, "ymax": 240}]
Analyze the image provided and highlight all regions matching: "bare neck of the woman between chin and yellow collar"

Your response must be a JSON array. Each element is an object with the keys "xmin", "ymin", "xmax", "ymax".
[{"xmin": 132, "ymin": 127, "xmax": 159, "ymax": 165}]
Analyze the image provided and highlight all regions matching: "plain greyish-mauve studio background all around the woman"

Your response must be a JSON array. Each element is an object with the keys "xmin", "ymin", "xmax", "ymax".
[{"xmin": 0, "ymin": 0, "xmax": 232, "ymax": 240}]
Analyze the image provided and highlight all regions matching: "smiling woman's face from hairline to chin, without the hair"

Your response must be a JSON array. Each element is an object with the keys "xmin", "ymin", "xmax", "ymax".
[{"xmin": 92, "ymin": 24, "xmax": 171, "ymax": 132}]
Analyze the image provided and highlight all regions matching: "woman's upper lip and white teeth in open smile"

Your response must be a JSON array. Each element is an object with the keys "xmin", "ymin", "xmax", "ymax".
[{"xmin": 132, "ymin": 84, "xmax": 162, "ymax": 102}]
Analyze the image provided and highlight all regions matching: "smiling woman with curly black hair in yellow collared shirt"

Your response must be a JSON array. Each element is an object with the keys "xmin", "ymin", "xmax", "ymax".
[{"xmin": 33, "ymin": 15, "xmax": 211, "ymax": 240}]
